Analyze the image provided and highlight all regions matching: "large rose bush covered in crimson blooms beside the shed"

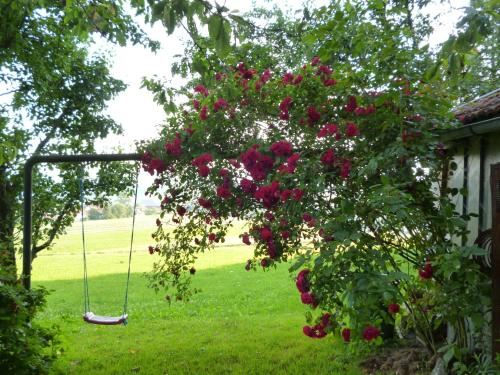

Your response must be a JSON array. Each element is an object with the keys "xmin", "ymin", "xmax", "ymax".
[{"xmin": 143, "ymin": 57, "xmax": 485, "ymax": 352}]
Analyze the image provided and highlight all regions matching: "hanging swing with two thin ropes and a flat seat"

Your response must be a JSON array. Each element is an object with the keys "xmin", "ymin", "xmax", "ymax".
[{"xmin": 79, "ymin": 168, "xmax": 139, "ymax": 325}]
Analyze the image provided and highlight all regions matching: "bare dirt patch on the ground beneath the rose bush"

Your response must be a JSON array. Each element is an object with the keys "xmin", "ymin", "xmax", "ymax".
[{"xmin": 361, "ymin": 347, "xmax": 435, "ymax": 375}]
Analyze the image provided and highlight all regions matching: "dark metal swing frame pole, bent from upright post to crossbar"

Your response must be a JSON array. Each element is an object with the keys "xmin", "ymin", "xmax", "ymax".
[{"xmin": 22, "ymin": 154, "xmax": 142, "ymax": 289}]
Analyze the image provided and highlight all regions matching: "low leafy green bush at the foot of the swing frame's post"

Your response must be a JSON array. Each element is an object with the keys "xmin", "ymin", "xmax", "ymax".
[{"xmin": 0, "ymin": 269, "xmax": 58, "ymax": 375}]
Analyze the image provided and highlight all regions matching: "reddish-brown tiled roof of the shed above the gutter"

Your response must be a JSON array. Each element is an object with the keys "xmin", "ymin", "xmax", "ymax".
[{"xmin": 453, "ymin": 89, "xmax": 500, "ymax": 125}]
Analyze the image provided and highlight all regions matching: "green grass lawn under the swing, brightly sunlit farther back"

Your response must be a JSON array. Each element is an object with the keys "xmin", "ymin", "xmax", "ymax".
[{"xmin": 33, "ymin": 217, "xmax": 368, "ymax": 375}]
